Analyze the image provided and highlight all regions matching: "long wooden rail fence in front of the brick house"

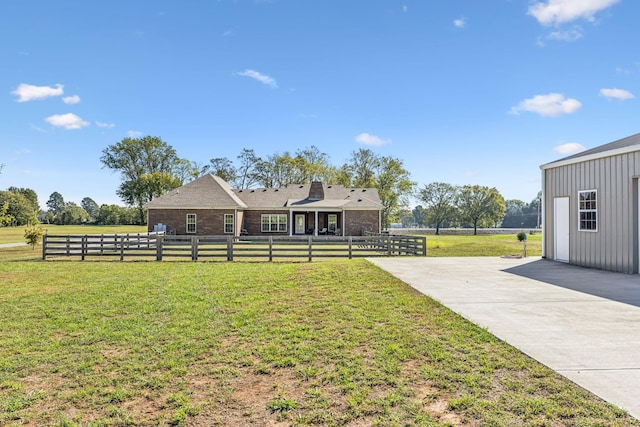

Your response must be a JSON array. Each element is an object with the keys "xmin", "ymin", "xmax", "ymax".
[{"xmin": 42, "ymin": 233, "xmax": 427, "ymax": 261}]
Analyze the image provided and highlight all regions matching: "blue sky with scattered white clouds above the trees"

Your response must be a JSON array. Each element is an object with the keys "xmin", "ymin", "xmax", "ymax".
[{"xmin": 0, "ymin": 0, "xmax": 640, "ymax": 208}]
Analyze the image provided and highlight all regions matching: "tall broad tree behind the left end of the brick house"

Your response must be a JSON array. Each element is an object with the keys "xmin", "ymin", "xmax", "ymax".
[{"xmin": 100, "ymin": 136, "xmax": 180, "ymax": 224}]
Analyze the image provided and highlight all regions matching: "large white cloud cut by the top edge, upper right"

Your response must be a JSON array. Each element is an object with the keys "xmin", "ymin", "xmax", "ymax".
[{"xmin": 527, "ymin": 0, "xmax": 619, "ymax": 25}]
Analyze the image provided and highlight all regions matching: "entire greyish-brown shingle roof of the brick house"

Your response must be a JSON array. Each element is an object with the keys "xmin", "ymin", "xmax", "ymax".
[{"xmin": 147, "ymin": 174, "xmax": 382, "ymax": 210}]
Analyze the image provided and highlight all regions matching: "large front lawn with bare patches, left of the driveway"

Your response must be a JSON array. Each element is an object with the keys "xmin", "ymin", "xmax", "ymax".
[{"xmin": 0, "ymin": 260, "xmax": 638, "ymax": 426}]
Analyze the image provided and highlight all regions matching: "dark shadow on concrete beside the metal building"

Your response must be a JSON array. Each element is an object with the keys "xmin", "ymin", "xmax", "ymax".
[{"xmin": 503, "ymin": 259, "xmax": 640, "ymax": 307}]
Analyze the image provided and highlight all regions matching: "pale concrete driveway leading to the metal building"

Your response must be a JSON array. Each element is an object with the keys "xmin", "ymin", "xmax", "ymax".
[{"xmin": 370, "ymin": 257, "xmax": 640, "ymax": 419}]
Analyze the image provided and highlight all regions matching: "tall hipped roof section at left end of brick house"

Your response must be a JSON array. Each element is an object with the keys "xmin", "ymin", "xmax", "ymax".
[{"xmin": 147, "ymin": 174, "xmax": 247, "ymax": 209}]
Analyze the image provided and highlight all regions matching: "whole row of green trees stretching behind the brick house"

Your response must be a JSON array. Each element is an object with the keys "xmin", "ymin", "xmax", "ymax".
[{"xmin": 0, "ymin": 136, "xmax": 540, "ymax": 232}]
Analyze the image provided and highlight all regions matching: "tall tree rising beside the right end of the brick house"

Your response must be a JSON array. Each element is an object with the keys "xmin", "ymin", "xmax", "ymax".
[{"xmin": 374, "ymin": 156, "xmax": 415, "ymax": 228}]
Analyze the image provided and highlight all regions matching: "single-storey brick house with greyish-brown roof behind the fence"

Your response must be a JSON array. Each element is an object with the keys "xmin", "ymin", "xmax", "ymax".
[{"xmin": 147, "ymin": 174, "xmax": 382, "ymax": 236}]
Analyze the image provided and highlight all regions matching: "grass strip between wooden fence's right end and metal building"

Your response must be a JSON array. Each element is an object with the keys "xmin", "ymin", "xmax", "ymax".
[{"xmin": 426, "ymin": 234, "xmax": 542, "ymax": 256}]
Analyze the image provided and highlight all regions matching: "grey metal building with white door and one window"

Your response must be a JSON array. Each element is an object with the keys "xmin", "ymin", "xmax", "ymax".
[{"xmin": 540, "ymin": 134, "xmax": 640, "ymax": 274}]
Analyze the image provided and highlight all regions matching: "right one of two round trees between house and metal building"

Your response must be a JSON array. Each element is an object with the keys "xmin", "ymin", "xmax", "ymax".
[{"xmin": 457, "ymin": 185, "xmax": 506, "ymax": 236}]
